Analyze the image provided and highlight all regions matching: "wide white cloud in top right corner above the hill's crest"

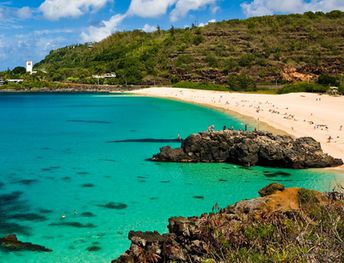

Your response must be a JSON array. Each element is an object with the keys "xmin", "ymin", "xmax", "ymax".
[{"xmin": 241, "ymin": 0, "xmax": 344, "ymax": 17}]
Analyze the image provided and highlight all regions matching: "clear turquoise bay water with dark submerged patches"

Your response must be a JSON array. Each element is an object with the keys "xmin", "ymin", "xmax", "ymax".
[{"xmin": 0, "ymin": 94, "xmax": 344, "ymax": 263}]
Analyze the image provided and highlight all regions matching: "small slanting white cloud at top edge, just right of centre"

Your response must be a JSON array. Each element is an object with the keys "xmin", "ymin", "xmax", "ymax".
[{"xmin": 170, "ymin": 0, "xmax": 216, "ymax": 22}]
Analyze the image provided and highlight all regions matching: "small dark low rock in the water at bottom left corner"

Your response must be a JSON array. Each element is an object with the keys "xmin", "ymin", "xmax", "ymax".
[{"xmin": 0, "ymin": 235, "xmax": 52, "ymax": 252}]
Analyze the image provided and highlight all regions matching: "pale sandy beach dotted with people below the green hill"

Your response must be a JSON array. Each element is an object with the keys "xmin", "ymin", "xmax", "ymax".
[{"xmin": 133, "ymin": 88, "xmax": 344, "ymax": 167}]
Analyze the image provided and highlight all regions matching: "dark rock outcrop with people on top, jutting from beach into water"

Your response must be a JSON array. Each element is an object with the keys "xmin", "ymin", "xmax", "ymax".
[{"xmin": 152, "ymin": 130, "xmax": 343, "ymax": 168}]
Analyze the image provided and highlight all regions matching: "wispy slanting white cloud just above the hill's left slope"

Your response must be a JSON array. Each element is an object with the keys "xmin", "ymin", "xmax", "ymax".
[{"xmin": 81, "ymin": 14, "xmax": 126, "ymax": 42}]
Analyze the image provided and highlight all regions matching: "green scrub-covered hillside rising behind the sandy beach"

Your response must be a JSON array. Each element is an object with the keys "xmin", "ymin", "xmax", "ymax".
[{"xmin": 36, "ymin": 11, "xmax": 344, "ymax": 84}]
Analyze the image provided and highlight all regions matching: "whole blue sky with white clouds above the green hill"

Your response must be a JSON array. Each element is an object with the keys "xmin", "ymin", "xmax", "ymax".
[{"xmin": 0, "ymin": 0, "xmax": 344, "ymax": 70}]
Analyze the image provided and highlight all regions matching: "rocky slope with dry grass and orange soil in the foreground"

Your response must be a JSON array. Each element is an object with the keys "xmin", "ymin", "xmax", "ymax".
[{"xmin": 113, "ymin": 184, "xmax": 344, "ymax": 263}]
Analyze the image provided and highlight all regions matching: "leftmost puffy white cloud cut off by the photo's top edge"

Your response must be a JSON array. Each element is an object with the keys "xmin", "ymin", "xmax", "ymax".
[{"xmin": 39, "ymin": 0, "xmax": 109, "ymax": 20}]
